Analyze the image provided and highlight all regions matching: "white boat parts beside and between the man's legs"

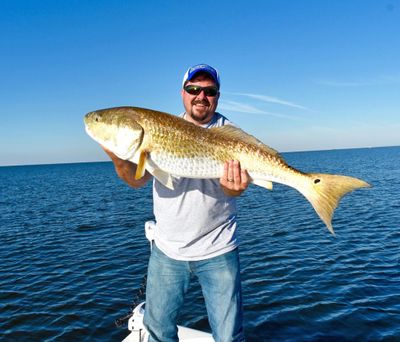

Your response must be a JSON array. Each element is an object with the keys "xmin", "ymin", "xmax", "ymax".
[{"xmin": 122, "ymin": 302, "xmax": 215, "ymax": 342}]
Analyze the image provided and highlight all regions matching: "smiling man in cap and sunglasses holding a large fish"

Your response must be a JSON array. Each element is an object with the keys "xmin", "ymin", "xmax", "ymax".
[{"xmin": 106, "ymin": 64, "xmax": 250, "ymax": 342}]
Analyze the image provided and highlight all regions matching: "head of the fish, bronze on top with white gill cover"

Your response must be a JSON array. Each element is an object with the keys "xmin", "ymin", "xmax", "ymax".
[{"xmin": 84, "ymin": 108, "xmax": 144, "ymax": 160}]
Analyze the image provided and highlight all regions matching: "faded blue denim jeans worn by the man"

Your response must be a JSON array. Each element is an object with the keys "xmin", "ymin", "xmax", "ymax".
[{"xmin": 144, "ymin": 244, "xmax": 244, "ymax": 342}]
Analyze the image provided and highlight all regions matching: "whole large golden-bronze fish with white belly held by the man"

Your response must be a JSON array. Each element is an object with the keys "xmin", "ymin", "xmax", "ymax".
[{"xmin": 85, "ymin": 107, "xmax": 369, "ymax": 233}]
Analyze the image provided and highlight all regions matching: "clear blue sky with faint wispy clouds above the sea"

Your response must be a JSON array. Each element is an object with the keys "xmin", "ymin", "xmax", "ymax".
[{"xmin": 0, "ymin": 0, "xmax": 400, "ymax": 165}]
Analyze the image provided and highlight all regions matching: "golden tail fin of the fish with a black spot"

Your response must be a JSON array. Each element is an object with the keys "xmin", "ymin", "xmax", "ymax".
[{"xmin": 301, "ymin": 173, "xmax": 371, "ymax": 235}]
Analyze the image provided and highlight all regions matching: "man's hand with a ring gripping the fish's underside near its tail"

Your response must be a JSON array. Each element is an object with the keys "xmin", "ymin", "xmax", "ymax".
[{"xmin": 219, "ymin": 160, "xmax": 251, "ymax": 196}]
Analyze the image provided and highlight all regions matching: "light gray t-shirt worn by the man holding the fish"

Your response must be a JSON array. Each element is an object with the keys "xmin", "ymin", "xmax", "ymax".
[{"xmin": 153, "ymin": 113, "xmax": 238, "ymax": 261}]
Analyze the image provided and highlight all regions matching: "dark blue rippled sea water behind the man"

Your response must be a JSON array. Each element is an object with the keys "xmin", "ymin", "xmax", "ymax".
[{"xmin": 0, "ymin": 147, "xmax": 400, "ymax": 341}]
